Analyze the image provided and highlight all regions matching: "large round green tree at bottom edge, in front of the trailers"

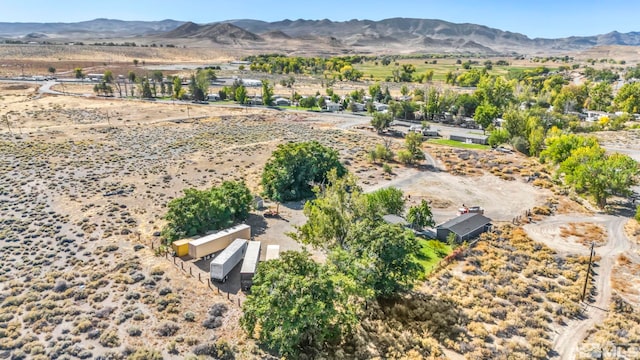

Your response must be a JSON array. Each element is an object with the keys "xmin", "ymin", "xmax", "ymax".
[{"xmin": 240, "ymin": 251, "xmax": 357, "ymax": 358}]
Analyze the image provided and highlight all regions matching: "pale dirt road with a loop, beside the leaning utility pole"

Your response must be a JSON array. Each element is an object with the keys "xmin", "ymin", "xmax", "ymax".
[{"xmin": 524, "ymin": 214, "xmax": 640, "ymax": 360}]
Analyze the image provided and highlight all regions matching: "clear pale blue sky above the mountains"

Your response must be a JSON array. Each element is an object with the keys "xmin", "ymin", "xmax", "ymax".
[{"xmin": 0, "ymin": 0, "xmax": 640, "ymax": 38}]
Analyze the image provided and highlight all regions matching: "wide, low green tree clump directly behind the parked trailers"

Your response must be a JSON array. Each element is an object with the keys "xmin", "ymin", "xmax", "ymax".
[{"xmin": 162, "ymin": 181, "xmax": 253, "ymax": 243}]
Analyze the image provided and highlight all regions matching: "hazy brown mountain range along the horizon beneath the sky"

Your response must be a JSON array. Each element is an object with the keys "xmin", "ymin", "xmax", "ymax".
[{"xmin": 0, "ymin": 18, "xmax": 640, "ymax": 54}]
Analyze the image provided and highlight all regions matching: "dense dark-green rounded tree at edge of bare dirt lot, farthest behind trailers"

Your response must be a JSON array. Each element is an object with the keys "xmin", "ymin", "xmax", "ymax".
[{"xmin": 262, "ymin": 141, "xmax": 346, "ymax": 202}]
